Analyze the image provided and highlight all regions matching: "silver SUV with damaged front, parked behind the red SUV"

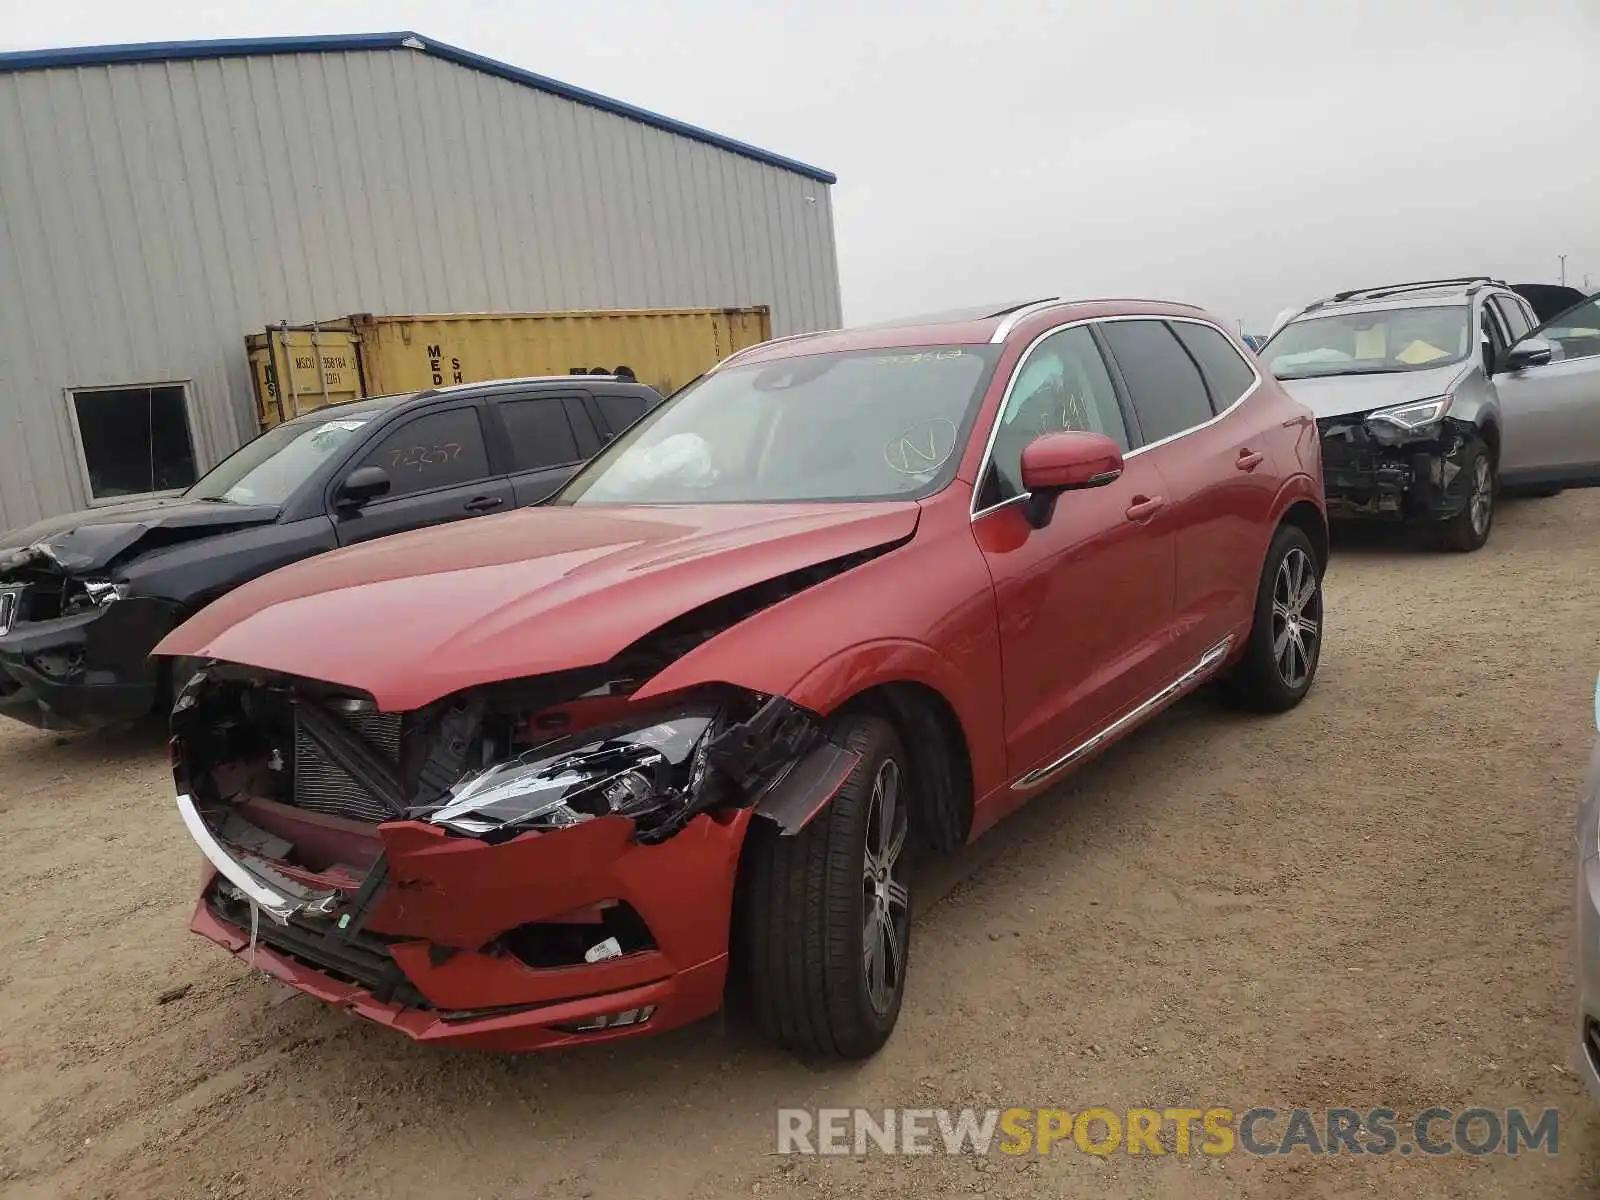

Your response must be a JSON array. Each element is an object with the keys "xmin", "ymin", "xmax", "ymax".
[{"xmin": 1261, "ymin": 277, "xmax": 1600, "ymax": 550}]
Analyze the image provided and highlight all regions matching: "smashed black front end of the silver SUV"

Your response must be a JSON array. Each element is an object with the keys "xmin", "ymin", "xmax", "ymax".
[{"xmin": 1317, "ymin": 413, "xmax": 1475, "ymax": 522}]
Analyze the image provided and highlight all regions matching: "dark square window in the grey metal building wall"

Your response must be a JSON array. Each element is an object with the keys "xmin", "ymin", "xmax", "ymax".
[{"xmin": 69, "ymin": 384, "xmax": 197, "ymax": 504}]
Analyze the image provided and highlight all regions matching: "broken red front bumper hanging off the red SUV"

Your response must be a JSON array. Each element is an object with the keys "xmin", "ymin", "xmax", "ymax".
[{"xmin": 190, "ymin": 813, "xmax": 749, "ymax": 1051}]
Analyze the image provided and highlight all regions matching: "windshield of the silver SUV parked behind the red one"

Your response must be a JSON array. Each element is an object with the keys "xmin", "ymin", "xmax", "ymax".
[{"xmin": 1261, "ymin": 304, "xmax": 1472, "ymax": 379}]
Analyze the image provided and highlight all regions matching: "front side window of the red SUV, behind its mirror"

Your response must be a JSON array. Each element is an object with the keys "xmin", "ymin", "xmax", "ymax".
[{"xmin": 978, "ymin": 325, "xmax": 1131, "ymax": 509}]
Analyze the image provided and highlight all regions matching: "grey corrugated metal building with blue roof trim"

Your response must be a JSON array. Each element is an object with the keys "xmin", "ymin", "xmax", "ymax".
[{"xmin": 0, "ymin": 34, "xmax": 840, "ymax": 530}]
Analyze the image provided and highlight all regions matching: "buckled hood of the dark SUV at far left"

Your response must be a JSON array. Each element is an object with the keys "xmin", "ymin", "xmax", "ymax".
[{"xmin": 0, "ymin": 498, "xmax": 278, "ymax": 573}]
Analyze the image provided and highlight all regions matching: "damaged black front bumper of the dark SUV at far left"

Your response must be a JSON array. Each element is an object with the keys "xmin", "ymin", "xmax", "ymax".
[{"xmin": 0, "ymin": 598, "xmax": 178, "ymax": 730}]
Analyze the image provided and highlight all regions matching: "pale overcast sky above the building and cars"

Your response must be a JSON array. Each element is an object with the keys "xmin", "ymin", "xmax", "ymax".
[{"xmin": 0, "ymin": 0, "xmax": 1600, "ymax": 330}]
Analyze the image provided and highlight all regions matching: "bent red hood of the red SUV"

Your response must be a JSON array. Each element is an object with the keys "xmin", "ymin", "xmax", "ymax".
[{"xmin": 155, "ymin": 502, "xmax": 920, "ymax": 710}]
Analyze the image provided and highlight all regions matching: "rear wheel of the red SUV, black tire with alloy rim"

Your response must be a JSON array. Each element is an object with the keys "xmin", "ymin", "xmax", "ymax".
[{"xmin": 1229, "ymin": 525, "xmax": 1323, "ymax": 712}]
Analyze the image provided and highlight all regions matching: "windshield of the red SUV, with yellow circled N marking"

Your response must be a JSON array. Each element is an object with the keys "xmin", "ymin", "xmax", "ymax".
[{"xmin": 554, "ymin": 346, "xmax": 998, "ymax": 504}]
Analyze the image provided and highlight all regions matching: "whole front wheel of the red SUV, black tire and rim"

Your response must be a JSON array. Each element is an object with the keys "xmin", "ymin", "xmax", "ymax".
[{"xmin": 742, "ymin": 717, "xmax": 910, "ymax": 1059}]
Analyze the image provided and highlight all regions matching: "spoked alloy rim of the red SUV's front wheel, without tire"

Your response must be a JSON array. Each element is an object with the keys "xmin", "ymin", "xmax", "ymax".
[{"xmin": 861, "ymin": 758, "xmax": 910, "ymax": 1016}]
